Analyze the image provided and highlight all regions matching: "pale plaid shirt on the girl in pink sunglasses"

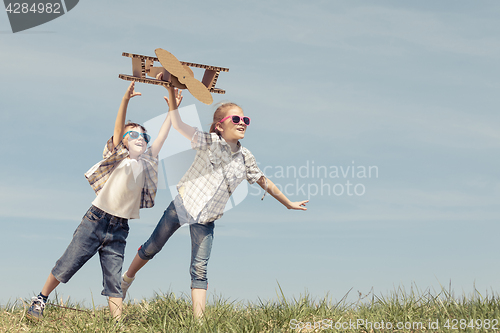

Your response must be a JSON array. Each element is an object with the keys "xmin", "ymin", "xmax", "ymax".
[{"xmin": 177, "ymin": 129, "xmax": 264, "ymax": 223}]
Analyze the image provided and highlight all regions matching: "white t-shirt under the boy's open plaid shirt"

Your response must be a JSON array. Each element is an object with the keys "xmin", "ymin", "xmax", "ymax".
[{"xmin": 92, "ymin": 158, "xmax": 144, "ymax": 219}]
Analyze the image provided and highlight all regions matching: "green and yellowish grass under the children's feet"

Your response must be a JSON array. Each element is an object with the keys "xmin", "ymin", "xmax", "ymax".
[{"xmin": 0, "ymin": 288, "xmax": 500, "ymax": 333}]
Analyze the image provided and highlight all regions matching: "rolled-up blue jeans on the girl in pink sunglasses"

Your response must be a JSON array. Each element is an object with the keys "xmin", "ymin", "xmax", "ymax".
[{"xmin": 138, "ymin": 201, "xmax": 215, "ymax": 290}]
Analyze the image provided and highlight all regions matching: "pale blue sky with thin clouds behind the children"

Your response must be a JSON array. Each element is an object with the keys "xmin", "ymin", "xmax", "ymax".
[{"xmin": 0, "ymin": 0, "xmax": 500, "ymax": 305}]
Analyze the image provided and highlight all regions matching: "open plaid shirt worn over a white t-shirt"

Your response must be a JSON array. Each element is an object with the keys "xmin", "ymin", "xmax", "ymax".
[{"xmin": 85, "ymin": 137, "xmax": 158, "ymax": 208}]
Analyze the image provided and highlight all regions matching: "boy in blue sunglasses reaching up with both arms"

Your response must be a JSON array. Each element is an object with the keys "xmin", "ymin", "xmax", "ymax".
[{"xmin": 28, "ymin": 82, "xmax": 182, "ymax": 319}]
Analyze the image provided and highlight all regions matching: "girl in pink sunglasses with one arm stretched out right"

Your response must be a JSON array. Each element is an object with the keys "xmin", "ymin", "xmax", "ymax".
[{"xmin": 122, "ymin": 88, "xmax": 309, "ymax": 318}]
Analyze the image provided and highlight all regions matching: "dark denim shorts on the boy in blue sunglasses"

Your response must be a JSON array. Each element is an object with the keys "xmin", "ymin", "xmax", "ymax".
[{"xmin": 52, "ymin": 206, "xmax": 129, "ymax": 297}]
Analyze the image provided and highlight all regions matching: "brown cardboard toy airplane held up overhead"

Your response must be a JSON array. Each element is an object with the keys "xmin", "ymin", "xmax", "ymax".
[{"xmin": 118, "ymin": 49, "xmax": 229, "ymax": 104}]
